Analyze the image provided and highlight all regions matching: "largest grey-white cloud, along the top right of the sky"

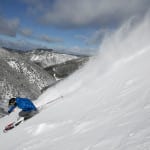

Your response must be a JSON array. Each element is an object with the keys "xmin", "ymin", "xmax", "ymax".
[{"xmin": 37, "ymin": 0, "xmax": 150, "ymax": 28}]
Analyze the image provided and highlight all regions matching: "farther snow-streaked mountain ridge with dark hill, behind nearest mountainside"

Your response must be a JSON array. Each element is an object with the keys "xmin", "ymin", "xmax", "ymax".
[{"xmin": 24, "ymin": 49, "xmax": 89, "ymax": 78}]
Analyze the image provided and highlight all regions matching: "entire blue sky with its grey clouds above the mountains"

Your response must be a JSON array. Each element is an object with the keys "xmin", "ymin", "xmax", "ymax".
[{"xmin": 0, "ymin": 0, "xmax": 150, "ymax": 54}]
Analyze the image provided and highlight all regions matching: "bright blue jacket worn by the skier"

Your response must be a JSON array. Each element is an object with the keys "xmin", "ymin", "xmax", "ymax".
[{"xmin": 8, "ymin": 97, "xmax": 37, "ymax": 113}]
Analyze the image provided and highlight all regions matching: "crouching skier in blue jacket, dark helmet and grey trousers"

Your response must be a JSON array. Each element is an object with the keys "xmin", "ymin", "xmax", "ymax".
[{"xmin": 8, "ymin": 97, "xmax": 38, "ymax": 120}]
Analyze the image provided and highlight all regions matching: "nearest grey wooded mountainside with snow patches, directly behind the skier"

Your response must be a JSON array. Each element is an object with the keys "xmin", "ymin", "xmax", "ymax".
[{"xmin": 0, "ymin": 49, "xmax": 55, "ymax": 99}]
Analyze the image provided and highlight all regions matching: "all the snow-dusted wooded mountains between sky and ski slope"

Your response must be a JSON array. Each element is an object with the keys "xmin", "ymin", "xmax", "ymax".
[{"xmin": 0, "ymin": 48, "xmax": 89, "ymax": 114}]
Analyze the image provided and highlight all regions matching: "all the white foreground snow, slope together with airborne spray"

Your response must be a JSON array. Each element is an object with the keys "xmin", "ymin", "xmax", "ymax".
[{"xmin": 0, "ymin": 13, "xmax": 150, "ymax": 150}]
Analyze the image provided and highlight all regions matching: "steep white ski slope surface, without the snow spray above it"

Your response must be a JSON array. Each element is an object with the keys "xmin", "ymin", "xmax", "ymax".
[{"xmin": 0, "ymin": 40, "xmax": 150, "ymax": 150}]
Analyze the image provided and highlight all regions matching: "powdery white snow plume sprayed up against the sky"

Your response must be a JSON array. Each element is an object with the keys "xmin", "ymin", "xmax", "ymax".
[{"xmin": 98, "ymin": 13, "xmax": 150, "ymax": 62}]
